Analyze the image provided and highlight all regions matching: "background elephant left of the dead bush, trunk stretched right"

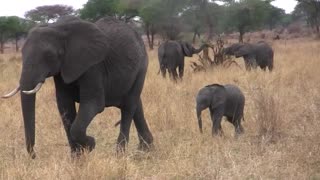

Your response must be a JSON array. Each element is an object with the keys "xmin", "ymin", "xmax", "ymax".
[{"xmin": 158, "ymin": 40, "xmax": 208, "ymax": 81}]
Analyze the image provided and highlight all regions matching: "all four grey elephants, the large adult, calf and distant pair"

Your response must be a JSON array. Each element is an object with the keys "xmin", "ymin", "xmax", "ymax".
[{"xmin": 3, "ymin": 16, "xmax": 273, "ymax": 158}]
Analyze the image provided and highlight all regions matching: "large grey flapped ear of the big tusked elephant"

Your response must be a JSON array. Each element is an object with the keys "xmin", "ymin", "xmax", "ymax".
[{"xmin": 53, "ymin": 19, "xmax": 109, "ymax": 83}]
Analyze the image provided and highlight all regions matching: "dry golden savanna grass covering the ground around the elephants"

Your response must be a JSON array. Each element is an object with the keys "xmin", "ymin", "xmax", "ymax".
[{"xmin": 0, "ymin": 39, "xmax": 320, "ymax": 180}]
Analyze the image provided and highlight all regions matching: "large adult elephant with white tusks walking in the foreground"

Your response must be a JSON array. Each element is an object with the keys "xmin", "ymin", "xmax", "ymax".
[{"xmin": 4, "ymin": 17, "xmax": 153, "ymax": 158}]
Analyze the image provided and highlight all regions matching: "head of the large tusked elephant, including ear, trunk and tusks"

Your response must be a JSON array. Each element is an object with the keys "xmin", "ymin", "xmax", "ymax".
[{"xmin": 4, "ymin": 17, "xmax": 109, "ymax": 158}]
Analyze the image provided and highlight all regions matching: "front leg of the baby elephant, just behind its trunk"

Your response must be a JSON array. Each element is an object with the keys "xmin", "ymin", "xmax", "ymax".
[{"xmin": 210, "ymin": 107, "xmax": 224, "ymax": 136}]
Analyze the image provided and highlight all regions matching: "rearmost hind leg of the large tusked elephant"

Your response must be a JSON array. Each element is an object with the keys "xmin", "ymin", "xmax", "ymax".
[{"xmin": 133, "ymin": 98, "xmax": 153, "ymax": 150}]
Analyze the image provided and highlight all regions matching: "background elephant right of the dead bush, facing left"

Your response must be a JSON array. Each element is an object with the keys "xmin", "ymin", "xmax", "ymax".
[{"xmin": 223, "ymin": 41, "xmax": 273, "ymax": 71}]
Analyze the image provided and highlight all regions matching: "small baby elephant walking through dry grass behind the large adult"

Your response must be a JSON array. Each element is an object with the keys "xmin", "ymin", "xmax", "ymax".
[{"xmin": 196, "ymin": 84, "xmax": 245, "ymax": 136}]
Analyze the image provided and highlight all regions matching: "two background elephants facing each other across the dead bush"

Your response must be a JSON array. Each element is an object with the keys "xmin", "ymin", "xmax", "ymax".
[{"xmin": 158, "ymin": 41, "xmax": 273, "ymax": 81}]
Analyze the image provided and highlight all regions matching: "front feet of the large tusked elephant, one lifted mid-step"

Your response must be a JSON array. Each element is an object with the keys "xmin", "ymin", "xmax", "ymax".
[{"xmin": 71, "ymin": 136, "xmax": 96, "ymax": 157}]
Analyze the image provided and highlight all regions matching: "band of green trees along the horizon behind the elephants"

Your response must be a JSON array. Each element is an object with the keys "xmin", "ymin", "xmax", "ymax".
[{"xmin": 0, "ymin": 0, "xmax": 320, "ymax": 53}]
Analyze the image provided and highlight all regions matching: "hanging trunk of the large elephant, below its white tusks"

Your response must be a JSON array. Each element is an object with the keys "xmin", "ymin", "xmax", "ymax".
[{"xmin": 21, "ymin": 92, "xmax": 36, "ymax": 159}]
